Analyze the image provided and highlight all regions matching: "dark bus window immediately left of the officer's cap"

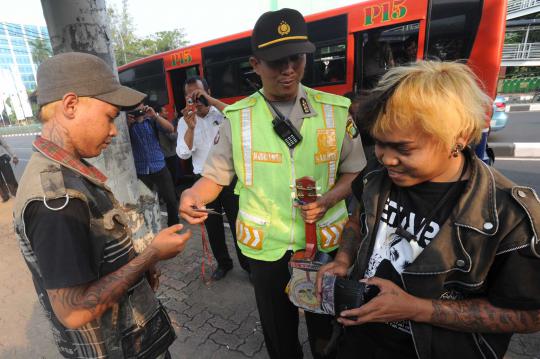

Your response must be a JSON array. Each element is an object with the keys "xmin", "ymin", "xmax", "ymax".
[{"xmin": 202, "ymin": 37, "xmax": 256, "ymax": 98}]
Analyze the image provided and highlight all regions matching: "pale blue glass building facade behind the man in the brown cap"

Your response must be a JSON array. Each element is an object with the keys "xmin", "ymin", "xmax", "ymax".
[{"xmin": 0, "ymin": 22, "xmax": 50, "ymax": 91}]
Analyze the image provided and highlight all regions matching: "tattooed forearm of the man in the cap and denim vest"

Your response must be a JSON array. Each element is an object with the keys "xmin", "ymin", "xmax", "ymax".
[{"xmin": 48, "ymin": 247, "xmax": 157, "ymax": 325}]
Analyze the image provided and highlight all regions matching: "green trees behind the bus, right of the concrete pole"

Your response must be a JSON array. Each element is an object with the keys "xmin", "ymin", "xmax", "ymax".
[{"xmin": 107, "ymin": 0, "xmax": 188, "ymax": 66}]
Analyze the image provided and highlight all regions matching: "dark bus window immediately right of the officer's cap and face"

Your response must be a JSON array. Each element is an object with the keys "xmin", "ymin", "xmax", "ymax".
[{"xmin": 302, "ymin": 15, "xmax": 347, "ymax": 87}]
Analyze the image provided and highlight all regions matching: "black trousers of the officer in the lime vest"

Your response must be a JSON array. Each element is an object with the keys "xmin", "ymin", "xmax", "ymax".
[{"xmin": 248, "ymin": 251, "xmax": 335, "ymax": 359}]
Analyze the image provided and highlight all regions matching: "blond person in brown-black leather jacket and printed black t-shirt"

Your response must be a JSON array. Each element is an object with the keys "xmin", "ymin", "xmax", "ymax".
[{"xmin": 317, "ymin": 61, "xmax": 540, "ymax": 359}]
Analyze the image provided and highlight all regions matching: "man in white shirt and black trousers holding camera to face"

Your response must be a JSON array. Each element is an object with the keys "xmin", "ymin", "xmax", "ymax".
[{"xmin": 176, "ymin": 76, "xmax": 249, "ymax": 280}]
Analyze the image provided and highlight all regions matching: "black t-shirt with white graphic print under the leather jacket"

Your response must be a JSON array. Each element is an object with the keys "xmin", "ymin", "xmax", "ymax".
[{"xmin": 362, "ymin": 181, "xmax": 466, "ymax": 358}]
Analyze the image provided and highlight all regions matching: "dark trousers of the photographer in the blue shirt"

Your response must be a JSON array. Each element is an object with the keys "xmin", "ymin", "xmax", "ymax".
[{"xmin": 137, "ymin": 166, "xmax": 179, "ymax": 227}]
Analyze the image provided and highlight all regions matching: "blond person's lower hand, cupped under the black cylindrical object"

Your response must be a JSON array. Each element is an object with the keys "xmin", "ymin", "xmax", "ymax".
[{"xmin": 336, "ymin": 277, "xmax": 431, "ymax": 326}]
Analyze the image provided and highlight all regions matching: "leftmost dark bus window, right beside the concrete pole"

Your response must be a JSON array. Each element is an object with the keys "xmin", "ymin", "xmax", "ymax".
[{"xmin": 118, "ymin": 59, "xmax": 169, "ymax": 105}]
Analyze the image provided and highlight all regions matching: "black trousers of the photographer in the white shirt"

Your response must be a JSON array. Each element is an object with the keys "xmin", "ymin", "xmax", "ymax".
[{"xmin": 204, "ymin": 177, "xmax": 249, "ymax": 272}]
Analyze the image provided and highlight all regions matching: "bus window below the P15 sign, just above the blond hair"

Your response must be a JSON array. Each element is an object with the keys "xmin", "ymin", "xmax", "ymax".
[{"xmin": 356, "ymin": 23, "xmax": 419, "ymax": 89}]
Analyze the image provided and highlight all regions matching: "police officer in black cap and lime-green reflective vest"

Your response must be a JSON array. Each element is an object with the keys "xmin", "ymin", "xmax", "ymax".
[{"xmin": 180, "ymin": 9, "xmax": 365, "ymax": 358}]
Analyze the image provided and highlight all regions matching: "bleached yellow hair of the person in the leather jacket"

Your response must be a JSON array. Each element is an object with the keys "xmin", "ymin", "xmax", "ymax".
[{"xmin": 371, "ymin": 61, "xmax": 491, "ymax": 148}]
